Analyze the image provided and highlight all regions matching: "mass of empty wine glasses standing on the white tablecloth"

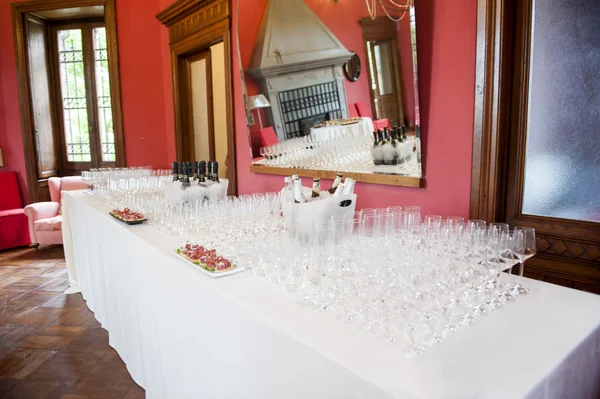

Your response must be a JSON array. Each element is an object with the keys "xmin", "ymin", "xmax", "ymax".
[{"xmin": 86, "ymin": 174, "xmax": 535, "ymax": 355}]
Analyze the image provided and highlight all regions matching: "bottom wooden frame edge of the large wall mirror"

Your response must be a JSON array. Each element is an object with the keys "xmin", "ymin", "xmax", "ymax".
[{"xmin": 250, "ymin": 164, "xmax": 424, "ymax": 188}]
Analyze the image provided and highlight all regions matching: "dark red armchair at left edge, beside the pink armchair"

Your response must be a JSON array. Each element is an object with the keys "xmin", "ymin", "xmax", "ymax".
[{"xmin": 0, "ymin": 172, "xmax": 31, "ymax": 250}]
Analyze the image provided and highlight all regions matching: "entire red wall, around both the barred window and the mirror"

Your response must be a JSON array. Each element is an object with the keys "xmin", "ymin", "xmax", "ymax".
[{"xmin": 0, "ymin": 0, "xmax": 476, "ymax": 216}]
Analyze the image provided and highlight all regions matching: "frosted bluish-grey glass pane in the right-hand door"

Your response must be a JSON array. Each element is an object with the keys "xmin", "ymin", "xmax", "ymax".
[{"xmin": 522, "ymin": 0, "xmax": 600, "ymax": 222}]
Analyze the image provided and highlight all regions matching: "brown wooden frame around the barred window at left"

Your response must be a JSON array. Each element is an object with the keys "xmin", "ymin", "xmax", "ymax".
[{"xmin": 11, "ymin": 0, "xmax": 125, "ymax": 202}]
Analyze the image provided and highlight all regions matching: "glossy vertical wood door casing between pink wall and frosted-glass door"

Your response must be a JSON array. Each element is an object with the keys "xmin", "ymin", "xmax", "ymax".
[{"xmin": 469, "ymin": 0, "xmax": 514, "ymax": 222}]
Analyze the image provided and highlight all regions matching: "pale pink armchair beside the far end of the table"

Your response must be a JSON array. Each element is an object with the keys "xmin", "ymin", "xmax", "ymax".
[{"xmin": 25, "ymin": 176, "xmax": 86, "ymax": 248}]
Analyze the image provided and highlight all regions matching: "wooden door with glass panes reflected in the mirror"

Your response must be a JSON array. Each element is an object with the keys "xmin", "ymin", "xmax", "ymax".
[{"xmin": 367, "ymin": 39, "xmax": 399, "ymax": 125}]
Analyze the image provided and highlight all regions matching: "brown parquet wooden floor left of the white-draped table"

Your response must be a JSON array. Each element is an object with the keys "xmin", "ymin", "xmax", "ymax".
[{"xmin": 0, "ymin": 246, "xmax": 145, "ymax": 399}]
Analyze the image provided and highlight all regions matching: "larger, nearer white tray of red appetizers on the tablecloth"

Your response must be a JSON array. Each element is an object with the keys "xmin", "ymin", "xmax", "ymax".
[{"xmin": 173, "ymin": 242, "xmax": 244, "ymax": 277}]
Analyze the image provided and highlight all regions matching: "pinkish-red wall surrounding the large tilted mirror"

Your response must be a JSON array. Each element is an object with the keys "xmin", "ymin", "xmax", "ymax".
[{"xmin": 234, "ymin": 0, "xmax": 477, "ymax": 217}]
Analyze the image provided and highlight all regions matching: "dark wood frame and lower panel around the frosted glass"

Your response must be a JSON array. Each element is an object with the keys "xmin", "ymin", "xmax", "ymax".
[{"xmin": 470, "ymin": 0, "xmax": 600, "ymax": 293}]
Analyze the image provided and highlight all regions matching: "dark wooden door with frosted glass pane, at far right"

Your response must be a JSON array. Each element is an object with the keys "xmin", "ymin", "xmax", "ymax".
[{"xmin": 506, "ymin": 0, "xmax": 600, "ymax": 293}]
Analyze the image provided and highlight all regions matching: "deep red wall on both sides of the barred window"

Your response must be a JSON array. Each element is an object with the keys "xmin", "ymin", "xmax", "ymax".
[{"xmin": 0, "ymin": 0, "xmax": 175, "ymax": 203}]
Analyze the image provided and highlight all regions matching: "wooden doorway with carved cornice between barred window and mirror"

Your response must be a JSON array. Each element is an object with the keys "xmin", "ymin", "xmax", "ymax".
[{"xmin": 157, "ymin": 0, "xmax": 237, "ymax": 194}]
